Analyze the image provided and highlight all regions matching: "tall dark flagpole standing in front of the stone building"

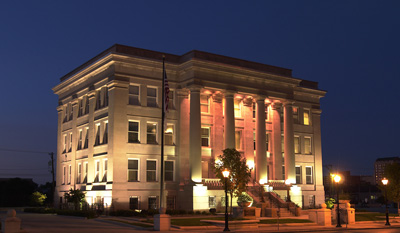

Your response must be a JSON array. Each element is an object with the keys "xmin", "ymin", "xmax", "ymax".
[{"xmin": 159, "ymin": 55, "xmax": 166, "ymax": 214}]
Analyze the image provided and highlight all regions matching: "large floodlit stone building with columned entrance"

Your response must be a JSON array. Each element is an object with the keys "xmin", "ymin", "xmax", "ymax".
[{"xmin": 53, "ymin": 45, "xmax": 325, "ymax": 210}]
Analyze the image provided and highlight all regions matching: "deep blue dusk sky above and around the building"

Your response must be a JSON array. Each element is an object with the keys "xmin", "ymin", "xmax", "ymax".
[{"xmin": 0, "ymin": 0, "xmax": 400, "ymax": 183}]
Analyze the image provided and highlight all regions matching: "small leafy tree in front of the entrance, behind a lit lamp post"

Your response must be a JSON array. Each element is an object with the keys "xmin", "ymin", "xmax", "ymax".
[{"xmin": 215, "ymin": 148, "xmax": 251, "ymax": 212}]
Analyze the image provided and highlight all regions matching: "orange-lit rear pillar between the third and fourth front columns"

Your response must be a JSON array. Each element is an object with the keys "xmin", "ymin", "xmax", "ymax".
[{"xmin": 271, "ymin": 102, "xmax": 282, "ymax": 180}]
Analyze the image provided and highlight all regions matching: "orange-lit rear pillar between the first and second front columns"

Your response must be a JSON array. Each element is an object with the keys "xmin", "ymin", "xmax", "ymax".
[{"xmin": 209, "ymin": 92, "xmax": 224, "ymax": 177}]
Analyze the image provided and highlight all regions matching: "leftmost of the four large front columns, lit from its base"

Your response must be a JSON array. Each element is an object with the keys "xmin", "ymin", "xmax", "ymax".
[{"xmin": 189, "ymin": 86, "xmax": 202, "ymax": 183}]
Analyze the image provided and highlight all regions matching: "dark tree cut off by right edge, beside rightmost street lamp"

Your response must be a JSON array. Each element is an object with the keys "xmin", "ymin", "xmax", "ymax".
[{"xmin": 379, "ymin": 163, "xmax": 400, "ymax": 215}]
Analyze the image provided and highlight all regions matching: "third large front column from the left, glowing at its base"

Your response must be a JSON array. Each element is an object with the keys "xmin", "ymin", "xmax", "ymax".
[{"xmin": 256, "ymin": 97, "xmax": 268, "ymax": 183}]
